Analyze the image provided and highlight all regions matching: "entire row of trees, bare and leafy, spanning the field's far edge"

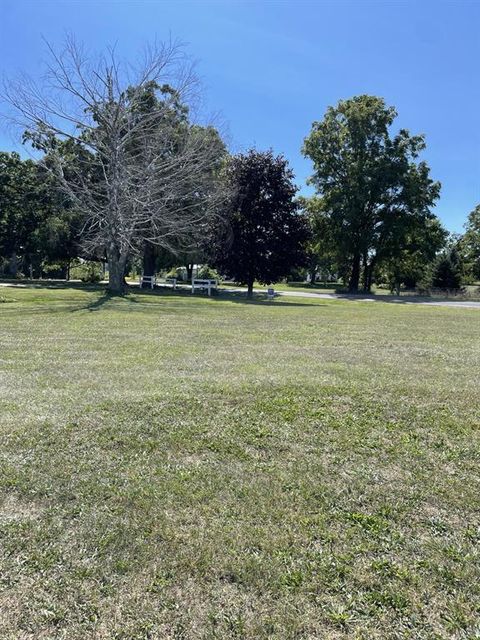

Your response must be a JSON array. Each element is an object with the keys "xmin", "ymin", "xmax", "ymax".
[{"xmin": 0, "ymin": 39, "xmax": 480, "ymax": 295}]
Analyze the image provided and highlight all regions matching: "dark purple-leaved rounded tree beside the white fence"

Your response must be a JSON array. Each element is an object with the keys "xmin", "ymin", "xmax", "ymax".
[{"xmin": 211, "ymin": 149, "xmax": 308, "ymax": 296}]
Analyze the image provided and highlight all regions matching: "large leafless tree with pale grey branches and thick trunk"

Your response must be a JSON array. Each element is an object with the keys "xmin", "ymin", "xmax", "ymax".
[{"xmin": 4, "ymin": 39, "xmax": 227, "ymax": 292}]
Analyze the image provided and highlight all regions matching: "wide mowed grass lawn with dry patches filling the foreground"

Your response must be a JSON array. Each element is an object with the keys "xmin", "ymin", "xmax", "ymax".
[{"xmin": 0, "ymin": 287, "xmax": 480, "ymax": 640}]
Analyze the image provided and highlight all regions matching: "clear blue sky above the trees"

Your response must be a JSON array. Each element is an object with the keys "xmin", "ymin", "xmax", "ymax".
[{"xmin": 0, "ymin": 0, "xmax": 480, "ymax": 231}]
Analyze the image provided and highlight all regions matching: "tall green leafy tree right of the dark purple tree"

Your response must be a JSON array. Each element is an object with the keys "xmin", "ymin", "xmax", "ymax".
[{"xmin": 303, "ymin": 95, "xmax": 440, "ymax": 292}]
